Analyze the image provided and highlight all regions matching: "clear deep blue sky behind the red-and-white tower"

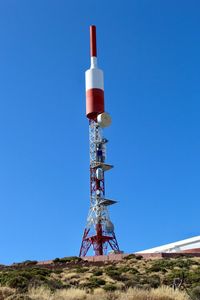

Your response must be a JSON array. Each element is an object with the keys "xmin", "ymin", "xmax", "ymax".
[{"xmin": 0, "ymin": 0, "xmax": 200, "ymax": 263}]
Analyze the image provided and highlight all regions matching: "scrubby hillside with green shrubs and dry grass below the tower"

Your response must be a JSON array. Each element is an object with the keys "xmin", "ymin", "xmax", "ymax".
[{"xmin": 0, "ymin": 255, "xmax": 200, "ymax": 300}]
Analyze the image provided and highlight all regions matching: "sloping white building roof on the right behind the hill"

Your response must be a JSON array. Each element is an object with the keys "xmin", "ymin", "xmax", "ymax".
[{"xmin": 137, "ymin": 235, "xmax": 200, "ymax": 253}]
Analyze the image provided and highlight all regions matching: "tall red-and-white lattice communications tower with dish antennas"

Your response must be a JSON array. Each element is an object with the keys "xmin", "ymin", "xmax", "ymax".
[{"xmin": 79, "ymin": 25, "xmax": 120, "ymax": 256}]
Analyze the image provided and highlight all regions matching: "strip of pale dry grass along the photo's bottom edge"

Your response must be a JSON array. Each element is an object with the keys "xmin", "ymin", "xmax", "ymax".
[{"xmin": 28, "ymin": 287, "xmax": 189, "ymax": 300}]
